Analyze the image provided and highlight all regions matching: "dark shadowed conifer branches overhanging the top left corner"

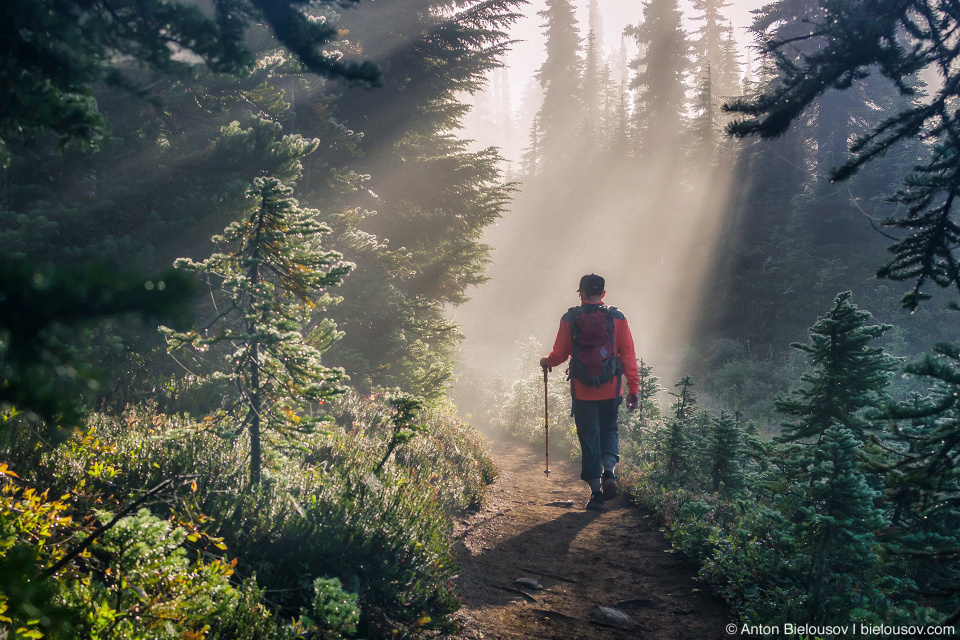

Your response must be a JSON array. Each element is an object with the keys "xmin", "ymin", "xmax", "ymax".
[{"xmin": 0, "ymin": 0, "xmax": 379, "ymax": 165}]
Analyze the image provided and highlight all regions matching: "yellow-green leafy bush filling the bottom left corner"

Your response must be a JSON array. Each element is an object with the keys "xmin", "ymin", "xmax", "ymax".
[{"xmin": 0, "ymin": 465, "xmax": 278, "ymax": 640}]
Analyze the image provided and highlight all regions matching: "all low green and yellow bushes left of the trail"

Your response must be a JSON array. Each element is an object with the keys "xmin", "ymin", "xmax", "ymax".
[{"xmin": 0, "ymin": 396, "xmax": 496, "ymax": 639}]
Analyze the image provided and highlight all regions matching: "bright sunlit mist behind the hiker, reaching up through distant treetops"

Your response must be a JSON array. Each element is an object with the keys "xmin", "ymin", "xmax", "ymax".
[{"xmin": 455, "ymin": 0, "xmax": 753, "ymax": 390}]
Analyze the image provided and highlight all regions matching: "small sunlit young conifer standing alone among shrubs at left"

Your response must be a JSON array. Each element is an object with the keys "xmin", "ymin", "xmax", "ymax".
[{"xmin": 165, "ymin": 176, "xmax": 352, "ymax": 485}]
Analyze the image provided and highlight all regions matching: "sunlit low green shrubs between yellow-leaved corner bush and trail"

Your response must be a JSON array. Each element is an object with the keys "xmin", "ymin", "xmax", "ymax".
[{"xmin": 0, "ymin": 397, "xmax": 495, "ymax": 638}]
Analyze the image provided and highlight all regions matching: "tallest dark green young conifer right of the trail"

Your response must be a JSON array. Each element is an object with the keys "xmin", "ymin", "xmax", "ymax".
[{"xmin": 773, "ymin": 291, "xmax": 897, "ymax": 621}]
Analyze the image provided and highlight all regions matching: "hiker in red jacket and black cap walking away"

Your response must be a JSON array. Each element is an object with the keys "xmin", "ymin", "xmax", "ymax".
[{"xmin": 540, "ymin": 273, "xmax": 640, "ymax": 509}]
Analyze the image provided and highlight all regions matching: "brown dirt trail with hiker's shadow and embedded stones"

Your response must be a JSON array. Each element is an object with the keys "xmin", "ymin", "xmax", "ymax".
[{"xmin": 456, "ymin": 441, "xmax": 737, "ymax": 640}]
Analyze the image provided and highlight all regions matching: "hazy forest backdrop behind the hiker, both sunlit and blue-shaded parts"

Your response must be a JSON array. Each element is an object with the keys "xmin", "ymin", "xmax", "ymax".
[{"xmin": 456, "ymin": 1, "xmax": 955, "ymax": 420}]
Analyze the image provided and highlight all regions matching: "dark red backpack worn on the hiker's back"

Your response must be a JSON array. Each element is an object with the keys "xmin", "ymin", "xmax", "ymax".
[{"xmin": 568, "ymin": 304, "xmax": 623, "ymax": 387}]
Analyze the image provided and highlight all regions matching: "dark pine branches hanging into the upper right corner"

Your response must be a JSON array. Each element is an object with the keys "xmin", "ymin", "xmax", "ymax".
[{"xmin": 730, "ymin": 0, "xmax": 960, "ymax": 309}]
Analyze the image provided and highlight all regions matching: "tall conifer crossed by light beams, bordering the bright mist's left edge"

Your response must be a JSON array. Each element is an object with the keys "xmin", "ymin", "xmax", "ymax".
[{"xmin": 320, "ymin": 0, "xmax": 518, "ymax": 397}]
